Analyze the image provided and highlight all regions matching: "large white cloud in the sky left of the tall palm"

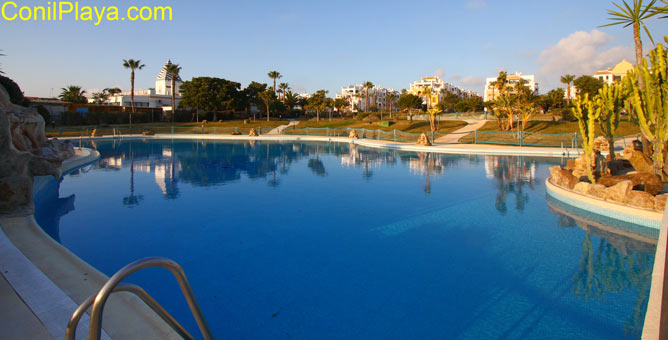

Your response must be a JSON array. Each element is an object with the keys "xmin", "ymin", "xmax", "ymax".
[{"xmin": 538, "ymin": 30, "xmax": 634, "ymax": 77}]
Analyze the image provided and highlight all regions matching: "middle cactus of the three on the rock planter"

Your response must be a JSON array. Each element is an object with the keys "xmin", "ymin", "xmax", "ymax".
[{"xmin": 594, "ymin": 82, "xmax": 626, "ymax": 160}]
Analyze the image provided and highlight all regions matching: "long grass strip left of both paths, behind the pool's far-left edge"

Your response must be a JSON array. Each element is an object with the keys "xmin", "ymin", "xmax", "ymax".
[{"xmin": 46, "ymin": 120, "xmax": 289, "ymax": 137}]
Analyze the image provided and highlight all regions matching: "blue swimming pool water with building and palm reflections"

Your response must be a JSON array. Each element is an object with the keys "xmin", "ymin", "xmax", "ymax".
[{"xmin": 36, "ymin": 140, "xmax": 656, "ymax": 339}]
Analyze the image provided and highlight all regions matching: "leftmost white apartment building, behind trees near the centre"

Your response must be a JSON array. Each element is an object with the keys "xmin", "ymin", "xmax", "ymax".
[{"xmin": 336, "ymin": 85, "xmax": 400, "ymax": 112}]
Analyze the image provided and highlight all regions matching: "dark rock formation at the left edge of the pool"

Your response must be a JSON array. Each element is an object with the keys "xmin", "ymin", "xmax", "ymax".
[{"xmin": 0, "ymin": 86, "xmax": 74, "ymax": 216}]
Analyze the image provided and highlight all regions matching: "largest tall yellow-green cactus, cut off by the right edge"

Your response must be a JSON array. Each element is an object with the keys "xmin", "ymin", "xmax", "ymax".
[{"xmin": 625, "ymin": 37, "xmax": 668, "ymax": 176}]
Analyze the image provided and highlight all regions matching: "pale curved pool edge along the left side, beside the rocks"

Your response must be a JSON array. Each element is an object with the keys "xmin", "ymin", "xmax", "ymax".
[{"xmin": 0, "ymin": 149, "xmax": 180, "ymax": 340}]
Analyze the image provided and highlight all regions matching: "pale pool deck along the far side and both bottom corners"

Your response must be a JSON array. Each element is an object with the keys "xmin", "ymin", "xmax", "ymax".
[{"xmin": 0, "ymin": 134, "xmax": 668, "ymax": 339}]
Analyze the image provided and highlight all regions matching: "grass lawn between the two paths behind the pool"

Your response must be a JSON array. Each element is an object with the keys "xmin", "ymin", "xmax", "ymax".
[{"xmin": 295, "ymin": 118, "xmax": 466, "ymax": 133}]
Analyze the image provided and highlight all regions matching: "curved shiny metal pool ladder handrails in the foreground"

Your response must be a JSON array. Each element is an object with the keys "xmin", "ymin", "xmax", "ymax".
[{"xmin": 65, "ymin": 257, "xmax": 213, "ymax": 340}]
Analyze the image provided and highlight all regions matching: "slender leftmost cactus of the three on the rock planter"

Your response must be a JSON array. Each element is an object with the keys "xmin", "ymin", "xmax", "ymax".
[{"xmin": 571, "ymin": 93, "xmax": 601, "ymax": 183}]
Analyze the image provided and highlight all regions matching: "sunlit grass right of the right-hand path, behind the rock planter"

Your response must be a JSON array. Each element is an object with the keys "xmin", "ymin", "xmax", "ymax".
[{"xmin": 460, "ymin": 121, "xmax": 640, "ymax": 146}]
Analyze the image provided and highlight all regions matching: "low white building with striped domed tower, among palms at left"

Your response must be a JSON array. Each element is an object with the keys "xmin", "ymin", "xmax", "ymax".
[{"xmin": 107, "ymin": 60, "xmax": 183, "ymax": 110}]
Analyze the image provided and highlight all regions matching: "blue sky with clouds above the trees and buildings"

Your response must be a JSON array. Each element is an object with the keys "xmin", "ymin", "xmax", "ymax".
[{"xmin": 0, "ymin": 0, "xmax": 668, "ymax": 96}]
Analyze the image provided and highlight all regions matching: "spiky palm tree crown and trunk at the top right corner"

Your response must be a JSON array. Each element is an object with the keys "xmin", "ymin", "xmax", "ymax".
[{"xmin": 600, "ymin": 0, "xmax": 660, "ymax": 65}]
